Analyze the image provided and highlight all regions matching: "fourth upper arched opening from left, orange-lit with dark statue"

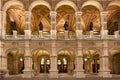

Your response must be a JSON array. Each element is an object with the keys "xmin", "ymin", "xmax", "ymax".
[{"xmin": 81, "ymin": 5, "xmax": 101, "ymax": 35}]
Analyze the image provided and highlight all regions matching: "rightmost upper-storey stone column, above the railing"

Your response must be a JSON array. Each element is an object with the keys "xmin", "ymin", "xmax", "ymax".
[{"xmin": 101, "ymin": 11, "xmax": 108, "ymax": 39}]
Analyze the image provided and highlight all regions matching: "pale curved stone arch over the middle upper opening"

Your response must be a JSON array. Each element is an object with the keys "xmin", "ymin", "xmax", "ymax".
[{"xmin": 55, "ymin": 0, "xmax": 78, "ymax": 11}]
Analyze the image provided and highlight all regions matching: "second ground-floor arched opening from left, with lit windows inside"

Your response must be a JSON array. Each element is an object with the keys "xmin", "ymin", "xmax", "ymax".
[{"xmin": 32, "ymin": 49, "xmax": 50, "ymax": 74}]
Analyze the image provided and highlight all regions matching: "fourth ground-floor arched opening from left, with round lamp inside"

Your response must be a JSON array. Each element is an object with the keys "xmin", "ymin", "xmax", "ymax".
[{"xmin": 83, "ymin": 50, "xmax": 100, "ymax": 73}]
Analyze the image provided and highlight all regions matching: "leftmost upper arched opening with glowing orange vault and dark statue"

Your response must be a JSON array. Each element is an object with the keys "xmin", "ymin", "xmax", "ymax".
[{"xmin": 5, "ymin": 5, "xmax": 25, "ymax": 35}]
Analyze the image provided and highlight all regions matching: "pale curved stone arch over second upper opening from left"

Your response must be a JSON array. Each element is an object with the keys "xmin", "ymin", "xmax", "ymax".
[{"xmin": 29, "ymin": 0, "xmax": 51, "ymax": 11}]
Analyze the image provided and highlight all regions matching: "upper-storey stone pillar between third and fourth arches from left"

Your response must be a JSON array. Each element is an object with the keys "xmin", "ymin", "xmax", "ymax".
[{"xmin": 76, "ymin": 11, "xmax": 82, "ymax": 39}]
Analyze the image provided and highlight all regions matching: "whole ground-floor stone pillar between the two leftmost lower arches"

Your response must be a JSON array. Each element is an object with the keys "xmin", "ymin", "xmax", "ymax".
[{"xmin": 22, "ymin": 40, "xmax": 33, "ymax": 78}]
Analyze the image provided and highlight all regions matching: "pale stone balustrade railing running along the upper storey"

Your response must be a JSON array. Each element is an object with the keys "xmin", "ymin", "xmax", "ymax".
[{"xmin": 3, "ymin": 35, "xmax": 120, "ymax": 40}]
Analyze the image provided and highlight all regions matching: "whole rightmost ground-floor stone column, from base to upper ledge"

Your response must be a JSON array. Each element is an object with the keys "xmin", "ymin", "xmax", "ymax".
[{"xmin": 99, "ymin": 40, "xmax": 112, "ymax": 77}]
